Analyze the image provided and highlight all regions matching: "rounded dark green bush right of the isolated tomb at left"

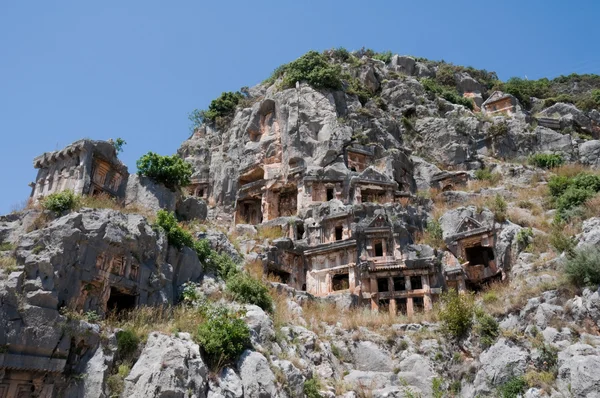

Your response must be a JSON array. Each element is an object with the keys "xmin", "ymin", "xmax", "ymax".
[{"xmin": 136, "ymin": 152, "xmax": 193, "ymax": 189}]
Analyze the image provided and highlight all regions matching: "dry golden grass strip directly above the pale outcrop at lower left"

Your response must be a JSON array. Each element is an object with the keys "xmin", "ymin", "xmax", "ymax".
[{"xmin": 103, "ymin": 306, "xmax": 204, "ymax": 341}]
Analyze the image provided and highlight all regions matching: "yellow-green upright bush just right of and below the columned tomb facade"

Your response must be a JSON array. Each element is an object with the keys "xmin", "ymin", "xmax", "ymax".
[{"xmin": 439, "ymin": 289, "xmax": 475, "ymax": 340}]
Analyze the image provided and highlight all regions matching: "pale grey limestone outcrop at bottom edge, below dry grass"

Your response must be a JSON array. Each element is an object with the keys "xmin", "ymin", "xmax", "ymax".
[{"xmin": 124, "ymin": 333, "xmax": 208, "ymax": 398}]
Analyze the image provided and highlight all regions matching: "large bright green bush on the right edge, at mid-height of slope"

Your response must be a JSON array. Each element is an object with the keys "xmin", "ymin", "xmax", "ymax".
[{"xmin": 548, "ymin": 172, "xmax": 600, "ymax": 220}]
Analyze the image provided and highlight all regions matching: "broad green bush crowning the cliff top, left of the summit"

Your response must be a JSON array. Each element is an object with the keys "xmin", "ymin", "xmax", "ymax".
[{"xmin": 282, "ymin": 51, "xmax": 342, "ymax": 90}]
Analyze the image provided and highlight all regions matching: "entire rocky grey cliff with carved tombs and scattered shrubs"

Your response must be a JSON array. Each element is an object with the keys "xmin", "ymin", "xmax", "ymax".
[{"xmin": 0, "ymin": 49, "xmax": 600, "ymax": 398}]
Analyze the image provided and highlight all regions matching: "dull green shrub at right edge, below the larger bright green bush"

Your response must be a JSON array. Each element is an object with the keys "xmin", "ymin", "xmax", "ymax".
[{"xmin": 565, "ymin": 246, "xmax": 600, "ymax": 286}]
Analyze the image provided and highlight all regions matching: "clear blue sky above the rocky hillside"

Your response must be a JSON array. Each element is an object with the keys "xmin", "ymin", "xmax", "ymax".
[{"xmin": 0, "ymin": 0, "xmax": 600, "ymax": 214}]
